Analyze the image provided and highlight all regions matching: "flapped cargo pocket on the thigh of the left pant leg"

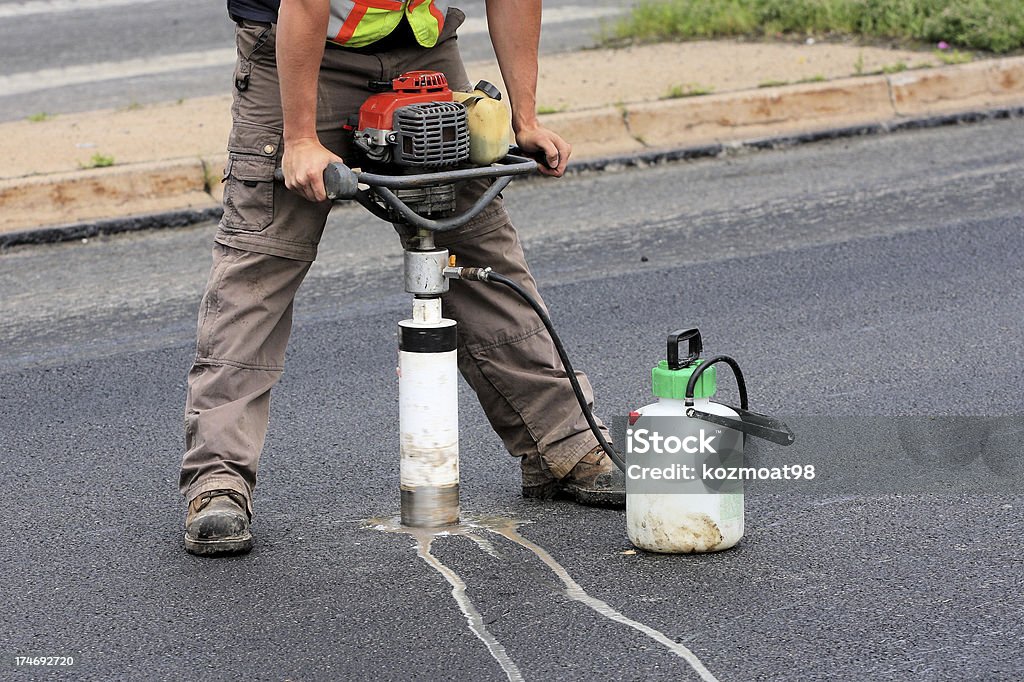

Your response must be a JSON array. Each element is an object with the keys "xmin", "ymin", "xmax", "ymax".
[{"xmin": 221, "ymin": 126, "xmax": 281, "ymax": 232}]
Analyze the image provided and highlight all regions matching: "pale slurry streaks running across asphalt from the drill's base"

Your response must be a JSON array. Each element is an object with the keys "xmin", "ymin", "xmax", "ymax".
[{"xmin": 367, "ymin": 515, "xmax": 717, "ymax": 682}]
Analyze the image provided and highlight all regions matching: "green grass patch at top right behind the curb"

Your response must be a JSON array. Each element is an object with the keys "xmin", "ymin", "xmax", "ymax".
[{"xmin": 604, "ymin": 0, "xmax": 1024, "ymax": 53}]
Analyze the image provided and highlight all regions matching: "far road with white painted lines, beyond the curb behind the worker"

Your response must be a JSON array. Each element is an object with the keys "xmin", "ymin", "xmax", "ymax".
[{"xmin": 0, "ymin": 0, "xmax": 632, "ymax": 121}]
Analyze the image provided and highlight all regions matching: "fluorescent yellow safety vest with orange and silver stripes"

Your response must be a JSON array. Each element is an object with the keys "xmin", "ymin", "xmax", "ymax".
[{"xmin": 327, "ymin": 0, "xmax": 447, "ymax": 47}]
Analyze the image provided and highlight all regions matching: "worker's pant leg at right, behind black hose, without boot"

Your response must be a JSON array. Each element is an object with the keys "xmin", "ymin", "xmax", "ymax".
[{"xmin": 437, "ymin": 197, "xmax": 597, "ymax": 473}]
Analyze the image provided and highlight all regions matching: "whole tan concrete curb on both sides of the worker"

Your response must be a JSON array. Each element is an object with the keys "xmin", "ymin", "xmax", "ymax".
[{"xmin": 0, "ymin": 57, "xmax": 1024, "ymax": 242}]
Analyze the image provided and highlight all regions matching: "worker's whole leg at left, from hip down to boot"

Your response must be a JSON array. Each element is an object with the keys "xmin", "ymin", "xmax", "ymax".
[{"xmin": 179, "ymin": 23, "xmax": 379, "ymax": 554}]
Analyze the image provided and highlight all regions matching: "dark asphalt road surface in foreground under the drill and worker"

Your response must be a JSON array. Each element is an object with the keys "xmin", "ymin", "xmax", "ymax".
[{"xmin": 0, "ymin": 121, "xmax": 1024, "ymax": 680}]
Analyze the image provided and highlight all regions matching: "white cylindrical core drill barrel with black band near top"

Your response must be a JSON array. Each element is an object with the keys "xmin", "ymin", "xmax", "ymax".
[{"xmin": 398, "ymin": 298, "xmax": 459, "ymax": 527}]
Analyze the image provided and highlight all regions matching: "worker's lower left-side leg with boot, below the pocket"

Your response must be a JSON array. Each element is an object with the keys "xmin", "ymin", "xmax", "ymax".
[{"xmin": 179, "ymin": 244, "xmax": 310, "ymax": 554}]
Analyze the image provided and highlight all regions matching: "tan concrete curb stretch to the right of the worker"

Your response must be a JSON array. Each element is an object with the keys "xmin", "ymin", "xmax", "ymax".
[{"xmin": 545, "ymin": 57, "xmax": 1024, "ymax": 156}]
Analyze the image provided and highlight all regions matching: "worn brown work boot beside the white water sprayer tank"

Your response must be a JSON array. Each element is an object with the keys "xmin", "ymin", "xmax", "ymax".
[{"xmin": 522, "ymin": 445, "xmax": 626, "ymax": 509}]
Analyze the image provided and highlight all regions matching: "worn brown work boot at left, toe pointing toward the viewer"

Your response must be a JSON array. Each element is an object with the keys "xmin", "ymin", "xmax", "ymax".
[{"xmin": 185, "ymin": 491, "xmax": 253, "ymax": 556}]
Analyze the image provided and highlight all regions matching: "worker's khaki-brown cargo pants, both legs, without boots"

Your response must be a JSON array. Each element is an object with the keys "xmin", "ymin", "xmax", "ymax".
[{"xmin": 179, "ymin": 9, "xmax": 596, "ymax": 512}]
